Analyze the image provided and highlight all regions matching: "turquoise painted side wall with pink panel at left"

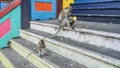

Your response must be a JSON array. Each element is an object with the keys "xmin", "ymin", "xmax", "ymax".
[{"xmin": 0, "ymin": 6, "xmax": 21, "ymax": 48}]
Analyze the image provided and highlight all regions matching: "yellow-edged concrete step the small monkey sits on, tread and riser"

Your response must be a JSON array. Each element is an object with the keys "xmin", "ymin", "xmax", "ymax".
[{"xmin": 10, "ymin": 38, "xmax": 87, "ymax": 68}]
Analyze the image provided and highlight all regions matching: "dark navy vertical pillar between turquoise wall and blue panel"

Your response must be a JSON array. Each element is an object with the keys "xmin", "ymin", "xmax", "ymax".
[{"xmin": 21, "ymin": 0, "xmax": 31, "ymax": 29}]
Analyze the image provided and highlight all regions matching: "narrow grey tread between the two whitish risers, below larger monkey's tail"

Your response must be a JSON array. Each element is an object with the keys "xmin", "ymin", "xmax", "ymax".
[{"xmin": 25, "ymin": 29, "xmax": 120, "ymax": 60}]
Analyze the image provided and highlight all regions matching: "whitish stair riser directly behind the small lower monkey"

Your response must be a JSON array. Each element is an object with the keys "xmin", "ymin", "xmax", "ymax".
[{"xmin": 20, "ymin": 31, "xmax": 119, "ymax": 68}]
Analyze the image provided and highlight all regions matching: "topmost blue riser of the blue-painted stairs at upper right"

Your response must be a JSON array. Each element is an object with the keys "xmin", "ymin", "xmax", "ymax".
[{"xmin": 72, "ymin": 2, "xmax": 120, "ymax": 9}]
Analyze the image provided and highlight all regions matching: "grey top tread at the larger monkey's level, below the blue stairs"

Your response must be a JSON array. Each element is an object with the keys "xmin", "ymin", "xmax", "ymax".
[{"xmin": 33, "ymin": 20, "xmax": 120, "ymax": 34}]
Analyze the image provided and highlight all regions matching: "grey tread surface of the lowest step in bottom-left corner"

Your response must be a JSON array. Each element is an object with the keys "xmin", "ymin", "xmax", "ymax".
[{"xmin": 1, "ymin": 48, "xmax": 35, "ymax": 68}]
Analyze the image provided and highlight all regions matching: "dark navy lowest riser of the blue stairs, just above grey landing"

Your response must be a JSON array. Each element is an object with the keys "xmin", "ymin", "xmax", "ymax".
[{"xmin": 73, "ymin": 15, "xmax": 120, "ymax": 24}]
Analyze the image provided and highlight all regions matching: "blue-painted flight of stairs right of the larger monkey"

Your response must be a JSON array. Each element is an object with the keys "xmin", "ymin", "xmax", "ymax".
[{"xmin": 71, "ymin": 0, "xmax": 120, "ymax": 24}]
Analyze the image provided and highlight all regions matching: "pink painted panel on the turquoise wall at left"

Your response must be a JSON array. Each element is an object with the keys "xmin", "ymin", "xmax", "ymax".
[{"xmin": 0, "ymin": 18, "xmax": 11, "ymax": 39}]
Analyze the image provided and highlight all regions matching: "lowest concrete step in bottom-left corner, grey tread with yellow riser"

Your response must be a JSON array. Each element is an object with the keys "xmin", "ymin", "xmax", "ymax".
[{"xmin": 0, "ymin": 48, "xmax": 36, "ymax": 68}]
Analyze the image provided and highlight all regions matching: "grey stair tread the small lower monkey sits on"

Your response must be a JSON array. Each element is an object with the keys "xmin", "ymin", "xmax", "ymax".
[{"xmin": 13, "ymin": 38, "xmax": 86, "ymax": 68}]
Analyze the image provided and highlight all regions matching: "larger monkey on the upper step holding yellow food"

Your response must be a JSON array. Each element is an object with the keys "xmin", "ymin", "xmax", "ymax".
[{"xmin": 54, "ymin": 6, "xmax": 77, "ymax": 36}]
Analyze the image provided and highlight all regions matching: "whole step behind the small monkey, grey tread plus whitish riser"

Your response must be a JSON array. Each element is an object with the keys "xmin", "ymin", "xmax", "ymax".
[{"xmin": 20, "ymin": 29, "xmax": 120, "ymax": 68}]
